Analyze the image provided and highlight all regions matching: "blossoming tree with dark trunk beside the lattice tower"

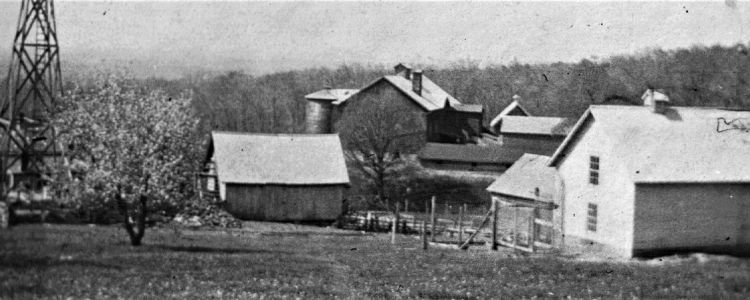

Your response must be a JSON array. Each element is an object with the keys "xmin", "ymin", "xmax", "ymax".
[{"xmin": 54, "ymin": 78, "xmax": 199, "ymax": 246}]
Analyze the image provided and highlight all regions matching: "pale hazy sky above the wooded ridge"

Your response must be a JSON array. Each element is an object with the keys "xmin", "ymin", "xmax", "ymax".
[{"xmin": 0, "ymin": 0, "xmax": 750, "ymax": 76}]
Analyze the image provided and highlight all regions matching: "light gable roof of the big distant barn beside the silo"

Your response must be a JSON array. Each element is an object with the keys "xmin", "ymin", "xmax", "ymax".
[{"xmin": 348, "ymin": 75, "xmax": 461, "ymax": 111}]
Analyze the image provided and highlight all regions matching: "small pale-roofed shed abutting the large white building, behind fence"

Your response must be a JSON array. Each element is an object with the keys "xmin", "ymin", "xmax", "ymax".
[{"xmin": 487, "ymin": 154, "xmax": 562, "ymax": 252}]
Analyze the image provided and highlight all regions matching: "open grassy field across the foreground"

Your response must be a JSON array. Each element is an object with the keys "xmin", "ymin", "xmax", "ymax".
[{"xmin": 0, "ymin": 223, "xmax": 750, "ymax": 299}]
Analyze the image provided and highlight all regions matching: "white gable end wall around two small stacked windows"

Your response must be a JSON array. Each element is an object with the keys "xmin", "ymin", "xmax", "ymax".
[{"xmin": 558, "ymin": 118, "xmax": 634, "ymax": 257}]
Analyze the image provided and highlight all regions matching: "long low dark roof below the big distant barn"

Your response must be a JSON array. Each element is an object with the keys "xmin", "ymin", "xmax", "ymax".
[{"xmin": 417, "ymin": 143, "xmax": 524, "ymax": 164}]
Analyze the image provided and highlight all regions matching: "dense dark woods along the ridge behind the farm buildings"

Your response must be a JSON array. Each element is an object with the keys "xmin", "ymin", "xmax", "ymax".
[{"xmin": 129, "ymin": 44, "xmax": 750, "ymax": 137}]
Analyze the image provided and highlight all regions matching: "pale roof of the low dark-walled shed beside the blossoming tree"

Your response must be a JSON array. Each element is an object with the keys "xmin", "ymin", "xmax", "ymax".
[{"xmin": 211, "ymin": 131, "xmax": 349, "ymax": 185}]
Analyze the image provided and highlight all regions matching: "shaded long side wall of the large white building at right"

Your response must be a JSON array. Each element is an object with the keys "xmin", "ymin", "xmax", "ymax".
[{"xmin": 633, "ymin": 183, "xmax": 750, "ymax": 253}]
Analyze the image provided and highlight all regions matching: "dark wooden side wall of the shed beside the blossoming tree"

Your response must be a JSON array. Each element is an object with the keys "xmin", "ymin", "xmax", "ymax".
[{"xmin": 226, "ymin": 183, "xmax": 344, "ymax": 221}]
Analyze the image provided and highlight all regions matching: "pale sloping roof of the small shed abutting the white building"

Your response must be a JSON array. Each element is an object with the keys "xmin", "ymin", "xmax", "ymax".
[{"xmin": 487, "ymin": 153, "xmax": 557, "ymax": 202}]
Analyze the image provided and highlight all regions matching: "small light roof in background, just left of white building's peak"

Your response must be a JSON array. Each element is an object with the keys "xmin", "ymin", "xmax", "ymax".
[{"xmin": 500, "ymin": 116, "xmax": 573, "ymax": 136}]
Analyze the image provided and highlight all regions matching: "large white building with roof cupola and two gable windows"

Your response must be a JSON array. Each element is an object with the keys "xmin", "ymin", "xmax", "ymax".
[{"xmin": 548, "ymin": 91, "xmax": 750, "ymax": 257}]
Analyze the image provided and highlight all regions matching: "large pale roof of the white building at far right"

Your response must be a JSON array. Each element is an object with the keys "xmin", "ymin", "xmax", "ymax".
[{"xmin": 549, "ymin": 105, "xmax": 750, "ymax": 183}]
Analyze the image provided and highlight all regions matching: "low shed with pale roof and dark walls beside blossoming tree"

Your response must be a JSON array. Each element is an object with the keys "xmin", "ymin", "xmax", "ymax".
[{"xmin": 207, "ymin": 131, "xmax": 349, "ymax": 221}]
